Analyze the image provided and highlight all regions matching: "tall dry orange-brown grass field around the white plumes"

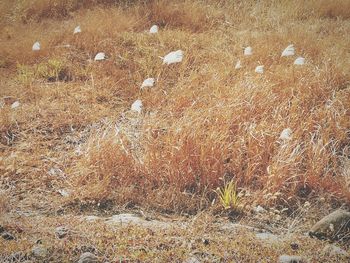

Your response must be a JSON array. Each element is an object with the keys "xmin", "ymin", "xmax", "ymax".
[{"xmin": 0, "ymin": 0, "xmax": 350, "ymax": 262}]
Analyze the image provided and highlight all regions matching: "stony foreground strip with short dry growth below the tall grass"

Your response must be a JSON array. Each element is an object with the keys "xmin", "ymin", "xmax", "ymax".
[{"xmin": 0, "ymin": 199, "xmax": 350, "ymax": 263}]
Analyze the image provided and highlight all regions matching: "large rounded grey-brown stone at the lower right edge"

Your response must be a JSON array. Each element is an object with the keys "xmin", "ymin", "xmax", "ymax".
[{"xmin": 309, "ymin": 209, "xmax": 350, "ymax": 240}]
